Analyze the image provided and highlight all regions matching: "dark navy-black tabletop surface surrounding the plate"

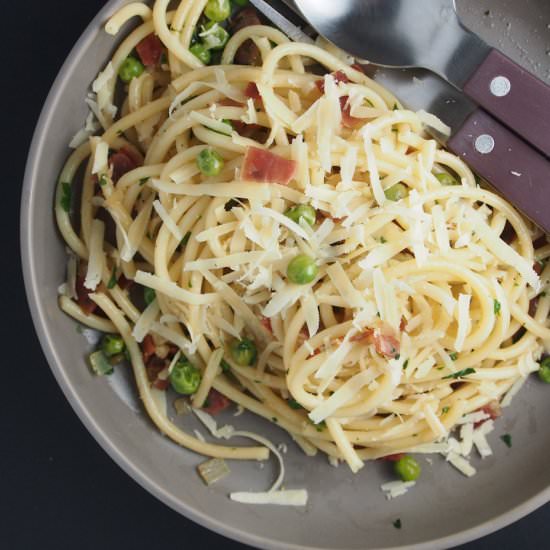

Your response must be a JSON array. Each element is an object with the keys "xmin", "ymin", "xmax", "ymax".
[{"xmin": 5, "ymin": 0, "xmax": 550, "ymax": 550}]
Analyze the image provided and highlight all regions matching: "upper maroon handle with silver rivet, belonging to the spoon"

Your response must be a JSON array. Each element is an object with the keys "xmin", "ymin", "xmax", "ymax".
[{"xmin": 464, "ymin": 49, "xmax": 550, "ymax": 160}]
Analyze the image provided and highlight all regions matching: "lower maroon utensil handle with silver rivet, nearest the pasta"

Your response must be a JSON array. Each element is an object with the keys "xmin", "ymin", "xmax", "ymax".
[{"xmin": 447, "ymin": 109, "xmax": 550, "ymax": 233}]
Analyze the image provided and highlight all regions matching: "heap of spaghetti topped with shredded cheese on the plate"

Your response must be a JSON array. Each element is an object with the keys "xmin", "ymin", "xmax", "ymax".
[{"xmin": 55, "ymin": 0, "xmax": 550, "ymax": 478}]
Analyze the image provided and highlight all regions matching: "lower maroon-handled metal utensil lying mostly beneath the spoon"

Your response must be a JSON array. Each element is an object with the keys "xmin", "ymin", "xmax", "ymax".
[{"xmin": 251, "ymin": 0, "xmax": 550, "ymax": 233}]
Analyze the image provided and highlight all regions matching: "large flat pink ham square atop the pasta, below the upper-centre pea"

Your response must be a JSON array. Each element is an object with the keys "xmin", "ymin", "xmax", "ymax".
[{"xmin": 241, "ymin": 147, "xmax": 298, "ymax": 185}]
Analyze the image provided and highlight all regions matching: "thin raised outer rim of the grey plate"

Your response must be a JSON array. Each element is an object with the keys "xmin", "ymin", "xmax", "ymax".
[{"xmin": 20, "ymin": 0, "xmax": 550, "ymax": 550}]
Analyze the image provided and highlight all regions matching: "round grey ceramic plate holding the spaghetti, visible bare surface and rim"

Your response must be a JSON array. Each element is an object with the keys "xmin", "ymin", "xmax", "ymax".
[{"xmin": 21, "ymin": 0, "xmax": 550, "ymax": 549}]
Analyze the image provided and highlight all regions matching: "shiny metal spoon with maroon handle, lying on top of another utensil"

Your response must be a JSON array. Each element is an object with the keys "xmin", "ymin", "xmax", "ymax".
[{"xmin": 296, "ymin": 0, "xmax": 550, "ymax": 160}]
